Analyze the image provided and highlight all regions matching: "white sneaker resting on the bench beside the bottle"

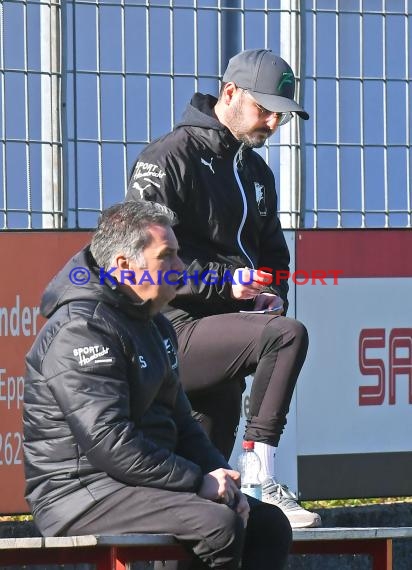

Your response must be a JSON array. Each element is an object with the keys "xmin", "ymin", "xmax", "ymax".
[{"xmin": 262, "ymin": 478, "xmax": 322, "ymax": 528}]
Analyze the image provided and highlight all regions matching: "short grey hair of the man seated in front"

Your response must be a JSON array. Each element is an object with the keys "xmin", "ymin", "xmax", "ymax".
[{"xmin": 90, "ymin": 200, "xmax": 176, "ymax": 271}]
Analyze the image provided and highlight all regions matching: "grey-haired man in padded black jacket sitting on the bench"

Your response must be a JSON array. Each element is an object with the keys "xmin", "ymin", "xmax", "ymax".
[{"xmin": 24, "ymin": 202, "xmax": 291, "ymax": 570}]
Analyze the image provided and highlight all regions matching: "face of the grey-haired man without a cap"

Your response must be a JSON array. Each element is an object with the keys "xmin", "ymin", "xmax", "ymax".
[{"xmin": 120, "ymin": 225, "xmax": 184, "ymax": 313}]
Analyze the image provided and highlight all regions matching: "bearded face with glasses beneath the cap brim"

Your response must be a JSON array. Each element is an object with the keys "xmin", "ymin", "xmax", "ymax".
[{"xmin": 225, "ymin": 87, "xmax": 279, "ymax": 148}]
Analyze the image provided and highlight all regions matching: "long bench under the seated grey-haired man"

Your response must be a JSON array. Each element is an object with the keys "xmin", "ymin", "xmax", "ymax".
[{"xmin": 0, "ymin": 527, "xmax": 412, "ymax": 570}]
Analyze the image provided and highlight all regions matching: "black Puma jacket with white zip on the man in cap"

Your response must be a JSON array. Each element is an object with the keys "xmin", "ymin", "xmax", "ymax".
[{"xmin": 126, "ymin": 93, "xmax": 289, "ymax": 324}]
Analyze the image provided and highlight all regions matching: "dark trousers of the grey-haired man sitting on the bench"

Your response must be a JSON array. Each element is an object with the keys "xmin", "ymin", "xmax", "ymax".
[{"xmin": 64, "ymin": 487, "xmax": 292, "ymax": 570}]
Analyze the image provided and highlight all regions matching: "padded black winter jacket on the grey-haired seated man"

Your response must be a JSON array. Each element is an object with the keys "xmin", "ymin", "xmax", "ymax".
[{"xmin": 23, "ymin": 248, "xmax": 228, "ymax": 536}]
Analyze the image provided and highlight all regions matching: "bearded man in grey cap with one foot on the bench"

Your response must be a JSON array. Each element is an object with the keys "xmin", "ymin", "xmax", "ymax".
[{"xmin": 126, "ymin": 49, "xmax": 321, "ymax": 528}]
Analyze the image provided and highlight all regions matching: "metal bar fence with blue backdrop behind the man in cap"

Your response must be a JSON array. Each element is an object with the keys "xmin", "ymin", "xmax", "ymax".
[{"xmin": 0, "ymin": 0, "xmax": 412, "ymax": 229}]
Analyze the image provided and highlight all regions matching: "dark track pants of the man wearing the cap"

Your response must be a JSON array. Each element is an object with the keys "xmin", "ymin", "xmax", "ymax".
[{"xmin": 173, "ymin": 313, "xmax": 308, "ymax": 458}]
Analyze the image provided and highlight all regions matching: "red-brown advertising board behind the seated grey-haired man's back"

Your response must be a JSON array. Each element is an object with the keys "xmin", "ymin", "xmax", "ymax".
[{"xmin": 0, "ymin": 231, "xmax": 90, "ymax": 514}]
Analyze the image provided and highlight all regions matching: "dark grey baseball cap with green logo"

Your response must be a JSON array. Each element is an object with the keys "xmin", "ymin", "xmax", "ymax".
[{"xmin": 223, "ymin": 49, "xmax": 309, "ymax": 120}]
